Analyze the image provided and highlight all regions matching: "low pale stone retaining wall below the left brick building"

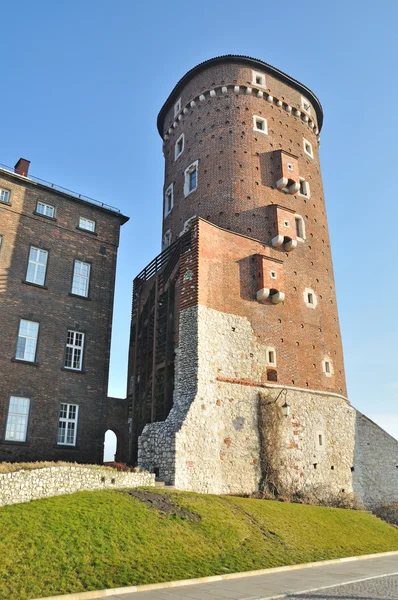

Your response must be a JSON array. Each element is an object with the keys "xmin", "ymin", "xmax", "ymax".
[{"xmin": 0, "ymin": 466, "xmax": 155, "ymax": 506}]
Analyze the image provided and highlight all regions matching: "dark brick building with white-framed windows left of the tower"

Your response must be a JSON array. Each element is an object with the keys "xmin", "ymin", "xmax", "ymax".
[{"xmin": 0, "ymin": 159, "xmax": 128, "ymax": 462}]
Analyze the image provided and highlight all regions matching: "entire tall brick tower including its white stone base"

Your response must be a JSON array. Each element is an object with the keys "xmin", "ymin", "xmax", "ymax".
[{"xmin": 129, "ymin": 56, "xmax": 398, "ymax": 505}]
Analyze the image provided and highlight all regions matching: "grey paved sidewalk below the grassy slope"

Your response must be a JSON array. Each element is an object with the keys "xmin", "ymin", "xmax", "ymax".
[{"xmin": 95, "ymin": 555, "xmax": 398, "ymax": 600}]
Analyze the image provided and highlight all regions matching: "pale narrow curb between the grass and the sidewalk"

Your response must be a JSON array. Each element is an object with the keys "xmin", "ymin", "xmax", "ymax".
[{"xmin": 34, "ymin": 550, "xmax": 398, "ymax": 600}]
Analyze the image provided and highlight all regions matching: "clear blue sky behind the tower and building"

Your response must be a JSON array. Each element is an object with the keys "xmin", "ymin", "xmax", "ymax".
[{"xmin": 0, "ymin": 0, "xmax": 398, "ymax": 436}]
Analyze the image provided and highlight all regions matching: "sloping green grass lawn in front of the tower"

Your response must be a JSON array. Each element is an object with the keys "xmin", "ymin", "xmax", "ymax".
[{"xmin": 0, "ymin": 491, "xmax": 398, "ymax": 600}]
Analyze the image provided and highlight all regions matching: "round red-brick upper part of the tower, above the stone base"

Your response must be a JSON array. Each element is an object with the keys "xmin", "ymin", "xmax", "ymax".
[{"xmin": 158, "ymin": 55, "xmax": 346, "ymax": 396}]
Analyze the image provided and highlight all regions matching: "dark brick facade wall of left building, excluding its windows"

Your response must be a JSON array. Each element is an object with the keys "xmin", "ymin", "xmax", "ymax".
[{"xmin": 0, "ymin": 173, "xmax": 125, "ymax": 462}]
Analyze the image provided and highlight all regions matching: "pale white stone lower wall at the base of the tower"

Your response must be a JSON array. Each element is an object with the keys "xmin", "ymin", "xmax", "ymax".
[{"xmin": 139, "ymin": 306, "xmax": 398, "ymax": 506}]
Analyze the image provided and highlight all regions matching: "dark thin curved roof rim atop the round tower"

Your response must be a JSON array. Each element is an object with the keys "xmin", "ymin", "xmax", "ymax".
[{"xmin": 157, "ymin": 54, "xmax": 323, "ymax": 137}]
